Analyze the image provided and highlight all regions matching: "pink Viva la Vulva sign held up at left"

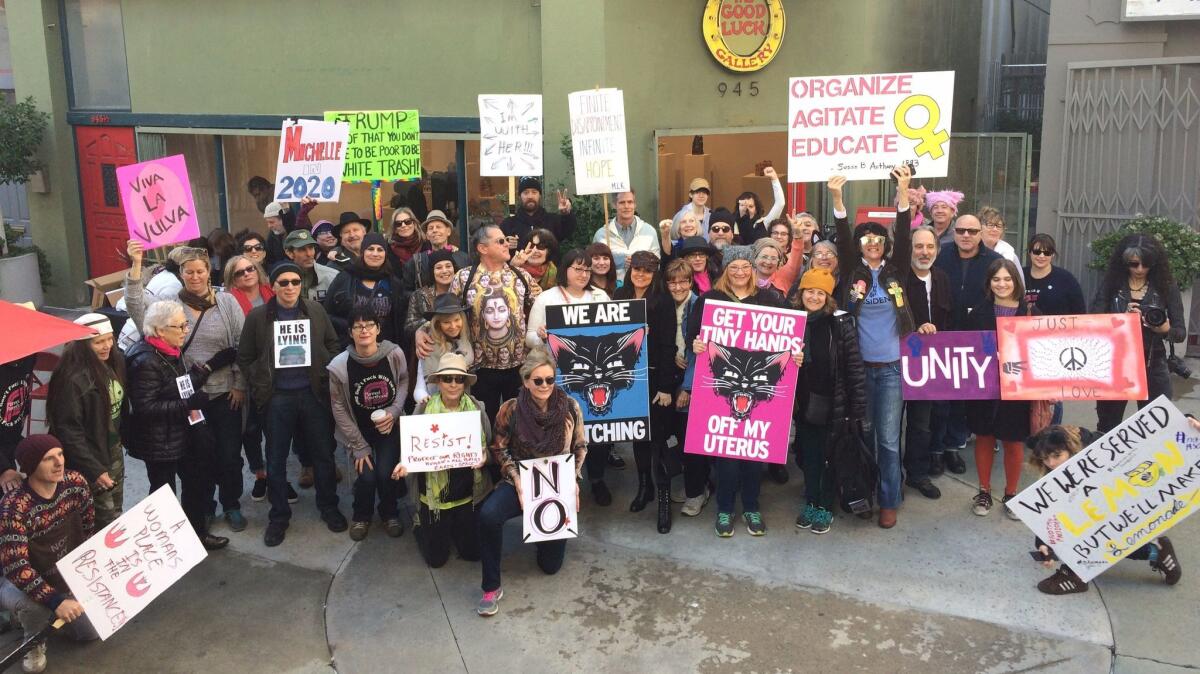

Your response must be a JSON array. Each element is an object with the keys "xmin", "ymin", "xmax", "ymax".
[{"xmin": 116, "ymin": 155, "xmax": 200, "ymax": 251}]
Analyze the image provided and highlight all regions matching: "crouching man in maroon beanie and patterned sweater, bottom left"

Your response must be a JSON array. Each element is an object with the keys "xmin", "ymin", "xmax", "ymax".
[{"xmin": 0, "ymin": 435, "xmax": 98, "ymax": 672}]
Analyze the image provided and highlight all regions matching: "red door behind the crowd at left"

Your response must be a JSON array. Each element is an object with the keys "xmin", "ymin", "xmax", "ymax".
[{"xmin": 76, "ymin": 126, "xmax": 138, "ymax": 278}]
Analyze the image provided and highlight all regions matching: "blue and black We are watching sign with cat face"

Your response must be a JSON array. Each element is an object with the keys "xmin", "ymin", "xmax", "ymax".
[{"xmin": 546, "ymin": 300, "xmax": 650, "ymax": 443}]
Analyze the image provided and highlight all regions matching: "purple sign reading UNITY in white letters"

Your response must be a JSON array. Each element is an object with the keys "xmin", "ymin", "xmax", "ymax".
[{"xmin": 900, "ymin": 330, "xmax": 1000, "ymax": 401}]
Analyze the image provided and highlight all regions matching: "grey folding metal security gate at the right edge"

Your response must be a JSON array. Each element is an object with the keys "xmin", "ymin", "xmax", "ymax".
[{"xmin": 1054, "ymin": 59, "xmax": 1200, "ymax": 299}]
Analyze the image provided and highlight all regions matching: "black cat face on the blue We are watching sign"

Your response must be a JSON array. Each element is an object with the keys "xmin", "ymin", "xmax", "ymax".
[{"xmin": 548, "ymin": 327, "xmax": 646, "ymax": 416}]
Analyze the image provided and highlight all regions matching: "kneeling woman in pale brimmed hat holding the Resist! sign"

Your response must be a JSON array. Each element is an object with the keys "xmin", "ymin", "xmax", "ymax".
[{"xmin": 391, "ymin": 353, "xmax": 492, "ymax": 568}]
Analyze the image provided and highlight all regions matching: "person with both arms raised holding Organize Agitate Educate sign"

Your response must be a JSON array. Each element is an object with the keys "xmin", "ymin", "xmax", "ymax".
[{"xmin": 828, "ymin": 164, "xmax": 916, "ymax": 529}]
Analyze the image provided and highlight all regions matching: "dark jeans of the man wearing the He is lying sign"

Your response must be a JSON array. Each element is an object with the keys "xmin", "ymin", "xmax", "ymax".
[{"xmin": 263, "ymin": 389, "xmax": 337, "ymax": 524}]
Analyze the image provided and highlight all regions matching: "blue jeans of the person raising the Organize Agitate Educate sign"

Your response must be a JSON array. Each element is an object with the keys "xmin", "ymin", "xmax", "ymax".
[{"xmin": 866, "ymin": 363, "xmax": 904, "ymax": 508}]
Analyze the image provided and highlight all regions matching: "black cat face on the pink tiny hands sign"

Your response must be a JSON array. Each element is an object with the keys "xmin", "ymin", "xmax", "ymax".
[{"xmin": 708, "ymin": 342, "xmax": 792, "ymax": 420}]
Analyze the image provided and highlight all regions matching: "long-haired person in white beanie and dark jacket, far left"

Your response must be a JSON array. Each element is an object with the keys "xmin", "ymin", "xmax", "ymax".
[{"xmin": 46, "ymin": 313, "xmax": 130, "ymax": 529}]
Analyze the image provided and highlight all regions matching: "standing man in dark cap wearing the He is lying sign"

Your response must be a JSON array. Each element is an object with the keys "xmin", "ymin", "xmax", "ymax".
[{"xmin": 238, "ymin": 254, "xmax": 345, "ymax": 547}]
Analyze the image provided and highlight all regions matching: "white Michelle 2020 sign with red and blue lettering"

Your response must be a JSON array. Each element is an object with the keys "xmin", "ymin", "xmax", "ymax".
[{"xmin": 275, "ymin": 119, "xmax": 349, "ymax": 201}]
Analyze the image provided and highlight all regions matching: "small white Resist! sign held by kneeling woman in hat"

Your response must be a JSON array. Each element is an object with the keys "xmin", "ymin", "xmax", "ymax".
[{"xmin": 400, "ymin": 411, "xmax": 484, "ymax": 473}]
